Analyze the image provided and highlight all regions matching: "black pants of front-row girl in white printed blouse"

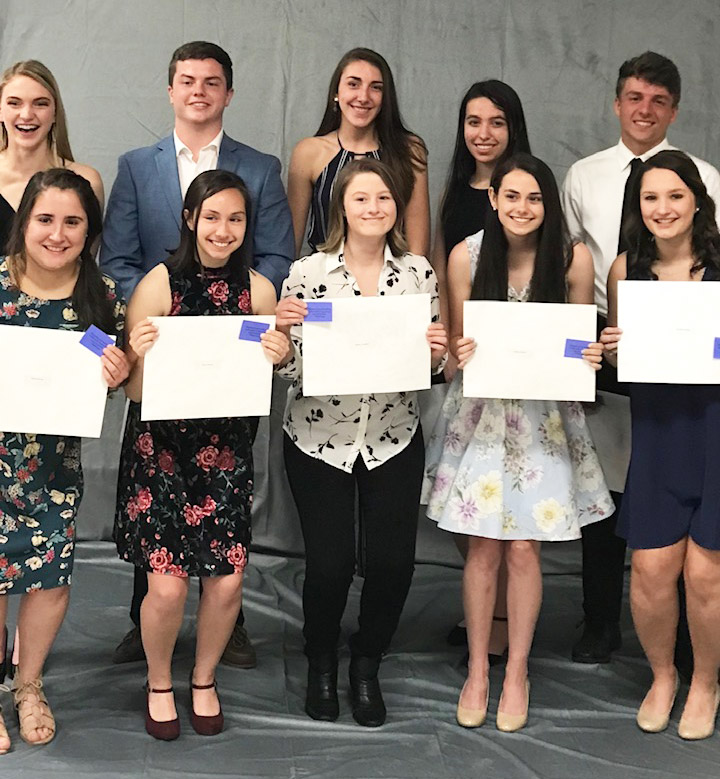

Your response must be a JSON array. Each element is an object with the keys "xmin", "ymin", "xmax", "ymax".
[{"xmin": 284, "ymin": 427, "xmax": 425, "ymax": 657}]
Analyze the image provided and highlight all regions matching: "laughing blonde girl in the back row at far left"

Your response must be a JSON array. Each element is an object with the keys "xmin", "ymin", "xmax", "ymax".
[{"xmin": 0, "ymin": 60, "xmax": 104, "ymax": 252}]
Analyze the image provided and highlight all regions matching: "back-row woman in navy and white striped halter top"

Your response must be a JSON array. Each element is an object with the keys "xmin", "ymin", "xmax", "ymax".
[{"xmin": 288, "ymin": 48, "xmax": 430, "ymax": 256}]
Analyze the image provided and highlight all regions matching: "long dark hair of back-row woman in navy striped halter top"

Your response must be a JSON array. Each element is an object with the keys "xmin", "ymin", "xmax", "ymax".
[{"xmin": 315, "ymin": 48, "xmax": 427, "ymax": 207}]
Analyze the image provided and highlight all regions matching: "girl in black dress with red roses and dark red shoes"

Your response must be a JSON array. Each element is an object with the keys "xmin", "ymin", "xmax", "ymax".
[{"xmin": 114, "ymin": 170, "xmax": 289, "ymax": 741}]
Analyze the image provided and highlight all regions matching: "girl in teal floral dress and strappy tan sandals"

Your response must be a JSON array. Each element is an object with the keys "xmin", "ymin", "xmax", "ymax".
[{"xmin": 0, "ymin": 169, "xmax": 128, "ymax": 753}]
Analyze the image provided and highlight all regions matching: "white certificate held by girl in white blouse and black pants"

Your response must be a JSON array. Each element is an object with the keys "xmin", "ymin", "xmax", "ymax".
[{"xmin": 302, "ymin": 294, "xmax": 432, "ymax": 395}]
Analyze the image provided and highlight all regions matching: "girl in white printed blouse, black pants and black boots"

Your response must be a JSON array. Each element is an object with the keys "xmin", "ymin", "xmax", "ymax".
[{"xmin": 277, "ymin": 159, "xmax": 447, "ymax": 727}]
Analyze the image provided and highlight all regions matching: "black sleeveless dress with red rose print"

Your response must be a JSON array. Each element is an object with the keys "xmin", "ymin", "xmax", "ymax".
[{"xmin": 113, "ymin": 268, "xmax": 258, "ymax": 576}]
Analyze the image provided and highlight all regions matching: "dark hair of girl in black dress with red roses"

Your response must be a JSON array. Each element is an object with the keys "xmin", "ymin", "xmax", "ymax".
[{"xmin": 168, "ymin": 170, "xmax": 252, "ymax": 281}]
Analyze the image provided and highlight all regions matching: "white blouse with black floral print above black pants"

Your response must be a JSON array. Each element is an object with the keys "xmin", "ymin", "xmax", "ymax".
[{"xmin": 278, "ymin": 245, "xmax": 442, "ymax": 473}]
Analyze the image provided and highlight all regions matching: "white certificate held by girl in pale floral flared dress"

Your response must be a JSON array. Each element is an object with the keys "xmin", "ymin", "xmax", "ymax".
[{"xmin": 463, "ymin": 300, "xmax": 597, "ymax": 400}]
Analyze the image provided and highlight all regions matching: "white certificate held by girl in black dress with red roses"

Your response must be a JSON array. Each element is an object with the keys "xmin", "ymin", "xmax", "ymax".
[{"xmin": 141, "ymin": 316, "xmax": 275, "ymax": 420}]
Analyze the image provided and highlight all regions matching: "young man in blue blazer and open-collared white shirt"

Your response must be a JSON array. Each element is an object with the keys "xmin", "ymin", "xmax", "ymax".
[{"xmin": 100, "ymin": 41, "xmax": 294, "ymax": 668}]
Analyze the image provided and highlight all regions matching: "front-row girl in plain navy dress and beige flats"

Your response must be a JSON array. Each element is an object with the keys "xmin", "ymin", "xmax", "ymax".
[{"xmin": 601, "ymin": 151, "xmax": 720, "ymax": 739}]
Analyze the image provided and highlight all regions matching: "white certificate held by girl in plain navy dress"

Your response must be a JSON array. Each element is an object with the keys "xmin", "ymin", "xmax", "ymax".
[{"xmin": 618, "ymin": 281, "xmax": 720, "ymax": 384}]
